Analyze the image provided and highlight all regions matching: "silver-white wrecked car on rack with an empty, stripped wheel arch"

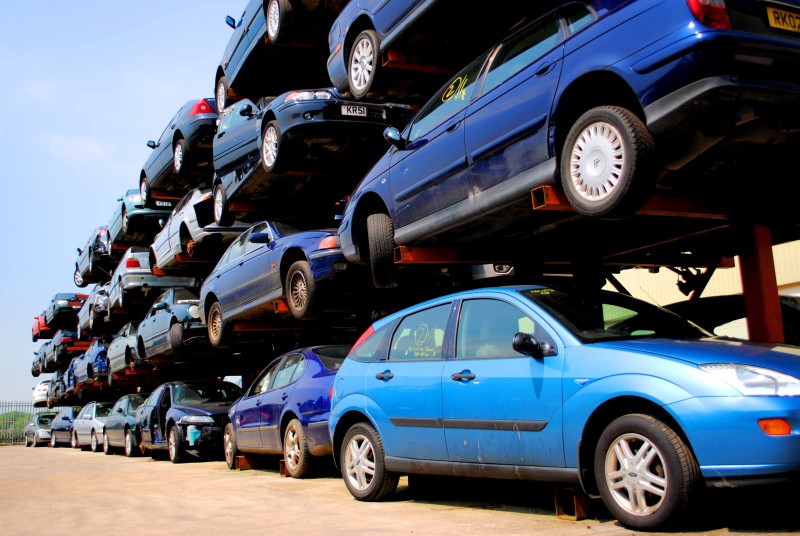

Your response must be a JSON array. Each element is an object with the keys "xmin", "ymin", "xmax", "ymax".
[{"xmin": 150, "ymin": 188, "xmax": 250, "ymax": 272}]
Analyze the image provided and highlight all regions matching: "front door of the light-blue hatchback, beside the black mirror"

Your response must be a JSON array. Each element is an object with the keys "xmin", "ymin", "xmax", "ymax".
[{"xmin": 442, "ymin": 298, "xmax": 564, "ymax": 467}]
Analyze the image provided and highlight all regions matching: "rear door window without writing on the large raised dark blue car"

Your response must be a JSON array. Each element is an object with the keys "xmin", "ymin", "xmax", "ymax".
[{"xmin": 483, "ymin": 14, "xmax": 561, "ymax": 93}]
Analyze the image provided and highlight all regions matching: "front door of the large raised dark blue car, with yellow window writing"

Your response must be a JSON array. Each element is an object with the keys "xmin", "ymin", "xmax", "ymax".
[{"xmin": 388, "ymin": 54, "xmax": 487, "ymax": 228}]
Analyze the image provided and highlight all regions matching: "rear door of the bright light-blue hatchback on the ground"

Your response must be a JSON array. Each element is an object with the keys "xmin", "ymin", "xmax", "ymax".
[{"xmin": 365, "ymin": 302, "xmax": 452, "ymax": 461}]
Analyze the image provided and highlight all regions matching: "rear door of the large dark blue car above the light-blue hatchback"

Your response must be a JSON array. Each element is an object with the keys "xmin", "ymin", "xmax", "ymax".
[{"xmin": 465, "ymin": 13, "xmax": 564, "ymax": 195}]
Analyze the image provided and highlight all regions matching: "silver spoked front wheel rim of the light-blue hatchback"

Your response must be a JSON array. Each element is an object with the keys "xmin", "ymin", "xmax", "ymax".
[{"xmin": 605, "ymin": 433, "xmax": 669, "ymax": 516}]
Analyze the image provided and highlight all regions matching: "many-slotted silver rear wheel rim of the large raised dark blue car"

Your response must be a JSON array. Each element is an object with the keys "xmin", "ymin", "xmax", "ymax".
[{"xmin": 569, "ymin": 121, "xmax": 627, "ymax": 201}]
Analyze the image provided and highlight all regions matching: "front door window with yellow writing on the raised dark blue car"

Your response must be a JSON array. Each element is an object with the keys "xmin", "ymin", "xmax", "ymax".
[{"xmin": 408, "ymin": 52, "xmax": 489, "ymax": 143}]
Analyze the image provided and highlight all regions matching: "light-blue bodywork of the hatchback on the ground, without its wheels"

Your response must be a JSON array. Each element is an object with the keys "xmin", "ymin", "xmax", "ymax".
[{"xmin": 330, "ymin": 286, "xmax": 800, "ymax": 489}]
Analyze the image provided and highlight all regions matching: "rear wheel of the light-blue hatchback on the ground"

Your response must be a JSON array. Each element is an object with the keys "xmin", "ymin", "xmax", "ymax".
[{"xmin": 341, "ymin": 423, "xmax": 399, "ymax": 501}]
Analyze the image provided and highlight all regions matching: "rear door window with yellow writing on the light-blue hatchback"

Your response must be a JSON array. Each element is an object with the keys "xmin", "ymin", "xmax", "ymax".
[{"xmin": 389, "ymin": 303, "xmax": 450, "ymax": 360}]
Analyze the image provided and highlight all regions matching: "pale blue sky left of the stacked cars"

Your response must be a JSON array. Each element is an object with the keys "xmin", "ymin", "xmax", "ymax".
[{"xmin": 0, "ymin": 0, "xmax": 246, "ymax": 401}]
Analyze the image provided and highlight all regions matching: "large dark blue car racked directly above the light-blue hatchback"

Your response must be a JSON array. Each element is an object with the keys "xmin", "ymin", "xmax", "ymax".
[{"xmin": 339, "ymin": 0, "xmax": 800, "ymax": 287}]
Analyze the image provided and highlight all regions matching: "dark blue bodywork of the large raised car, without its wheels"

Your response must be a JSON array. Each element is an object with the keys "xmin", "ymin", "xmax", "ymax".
[{"xmin": 332, "ymin": 0, "xmax": 800, "ymax": 263}]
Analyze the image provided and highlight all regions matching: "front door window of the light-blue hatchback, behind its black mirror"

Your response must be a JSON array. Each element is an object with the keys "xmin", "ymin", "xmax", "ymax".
[{"xmin": 456, "ymin": 299, "xmax": 555, "ymax": 358}]
